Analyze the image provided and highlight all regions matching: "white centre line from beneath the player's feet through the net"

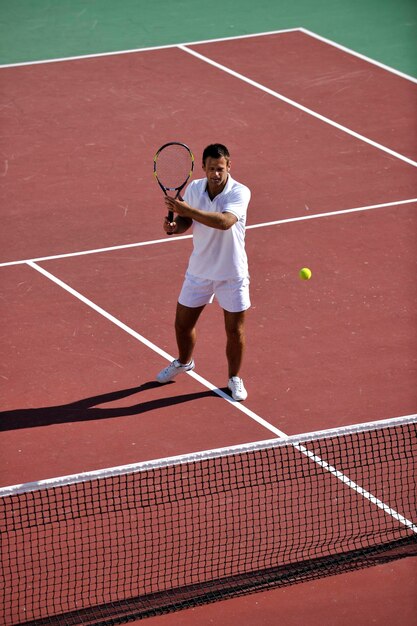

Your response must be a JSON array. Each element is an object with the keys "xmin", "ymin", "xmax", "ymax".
[{"xmin": 21, "ymin": 261, "xmax": 417, "ymax": 533}]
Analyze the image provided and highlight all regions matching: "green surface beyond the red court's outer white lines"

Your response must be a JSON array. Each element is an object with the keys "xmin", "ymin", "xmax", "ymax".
[{"xmin": 0, "ymin": 0, "xmax": 417, "ymax": 76}]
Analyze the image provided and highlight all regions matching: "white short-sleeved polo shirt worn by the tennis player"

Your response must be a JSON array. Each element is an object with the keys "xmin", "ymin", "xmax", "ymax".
[{"xmin": 184, "ymin": 174, "xmax": 251, "ymax": 280}]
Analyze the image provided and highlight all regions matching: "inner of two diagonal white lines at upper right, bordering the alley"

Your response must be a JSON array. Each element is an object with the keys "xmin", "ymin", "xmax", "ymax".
[{"xmin": 178, "ymin": 45, "xmax": 417, "ymax": 167}]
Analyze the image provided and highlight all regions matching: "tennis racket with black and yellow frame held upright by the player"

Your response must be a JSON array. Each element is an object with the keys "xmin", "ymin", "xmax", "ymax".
[{"xmin": 153, "ymin": 141, "xmax": 194, "ymax": 222}]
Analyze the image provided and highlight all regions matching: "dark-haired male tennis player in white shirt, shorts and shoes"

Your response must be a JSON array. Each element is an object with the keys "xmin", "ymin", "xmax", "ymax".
[{"xmin": 156, "ymin": 144, "xmax": 251, "ymax": 401}]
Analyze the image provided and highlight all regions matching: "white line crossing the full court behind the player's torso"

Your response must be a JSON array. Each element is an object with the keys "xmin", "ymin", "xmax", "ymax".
[{"xmin": 0, "ymin": 198, "xmax": 417, "ymax": 267}]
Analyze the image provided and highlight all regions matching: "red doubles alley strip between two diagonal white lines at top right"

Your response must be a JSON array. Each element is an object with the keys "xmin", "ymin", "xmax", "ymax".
[{"xmin": 188, "ymin": 32, "xmax": 417, "ymax": 159}]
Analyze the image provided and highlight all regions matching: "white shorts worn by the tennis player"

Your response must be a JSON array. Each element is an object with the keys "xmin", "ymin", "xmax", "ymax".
[{"xmin": 178, "ymin": 273, "xmax": 250, "ymax": 313}]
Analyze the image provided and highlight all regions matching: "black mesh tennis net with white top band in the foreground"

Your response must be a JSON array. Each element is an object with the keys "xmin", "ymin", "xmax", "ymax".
[{"xmin": 0, "ymin": 415, "xmax": 417, "ymax": 625}]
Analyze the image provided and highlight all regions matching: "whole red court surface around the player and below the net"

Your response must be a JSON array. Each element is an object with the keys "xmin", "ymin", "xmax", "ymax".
[{"xmin": 0, "ymin": 32, "xmax": 417, "ymax": 626}]
